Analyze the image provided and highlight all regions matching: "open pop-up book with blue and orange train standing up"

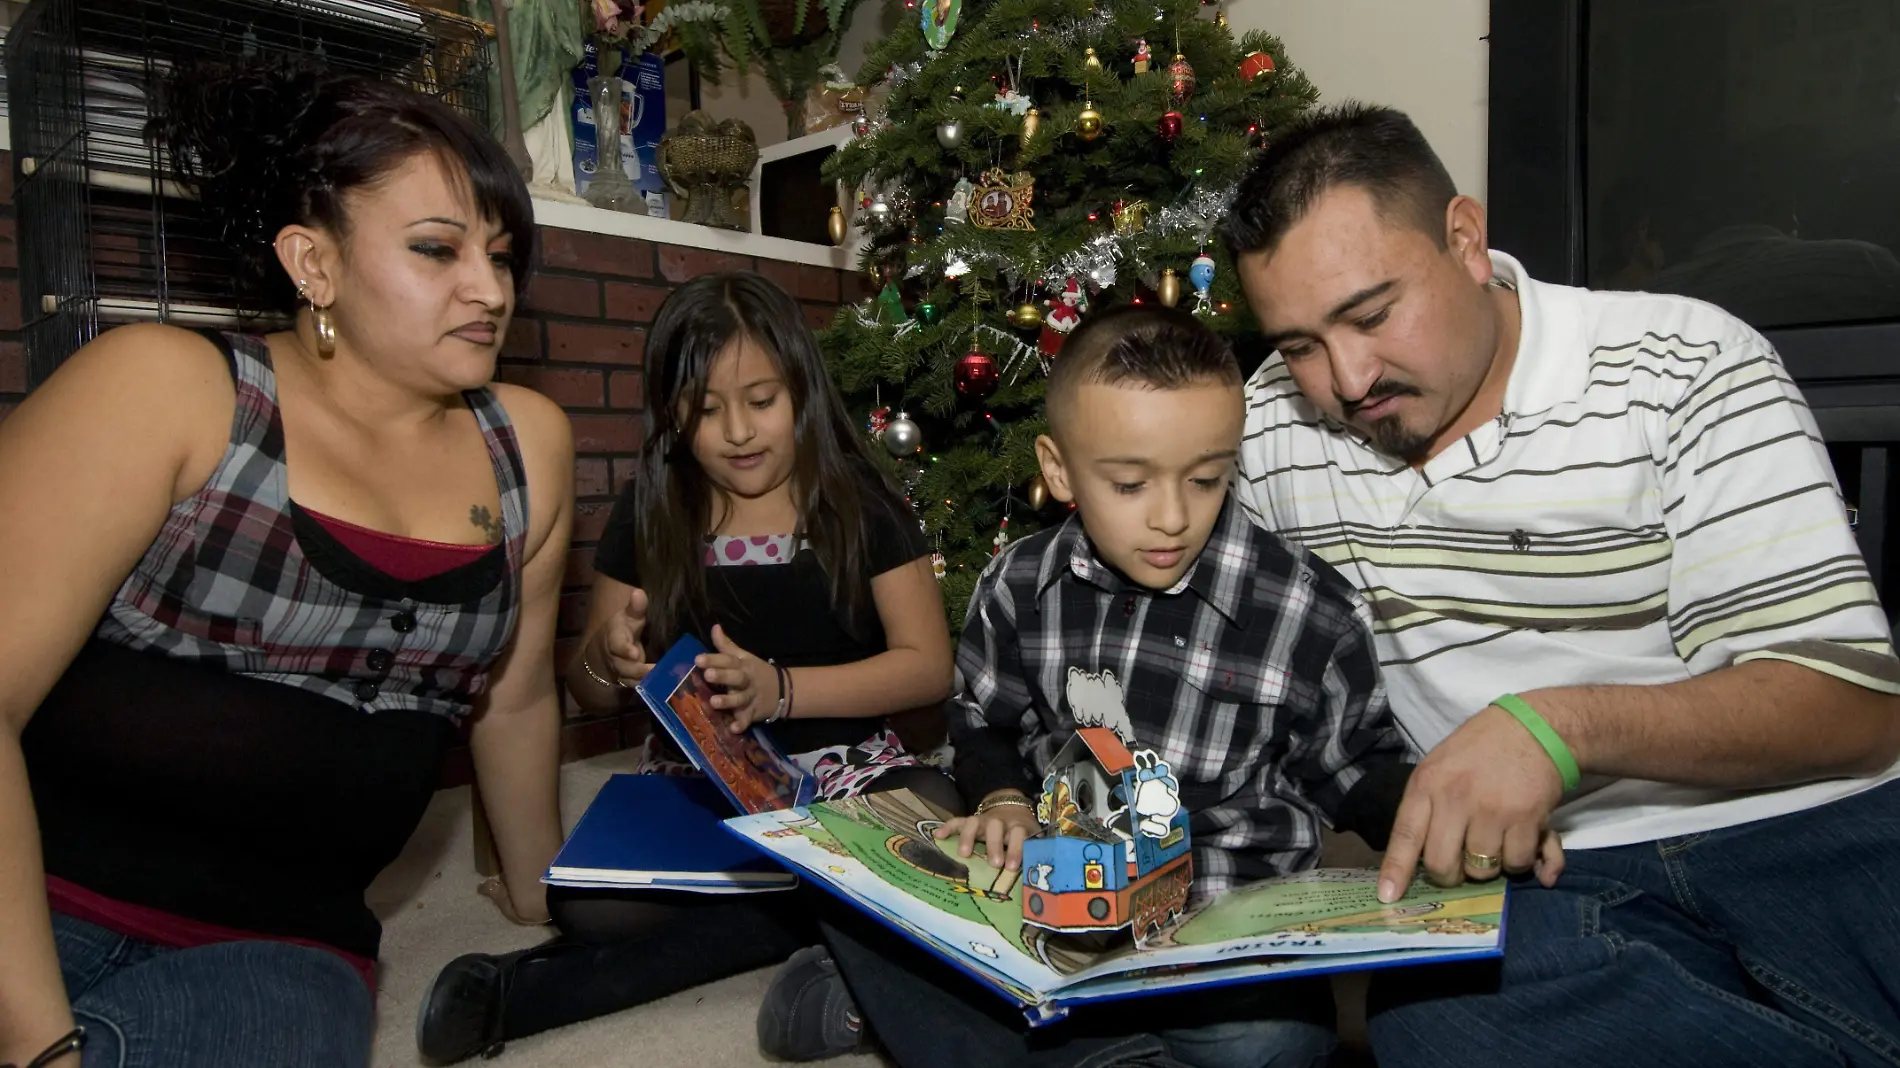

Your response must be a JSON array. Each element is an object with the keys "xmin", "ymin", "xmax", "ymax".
[{"xmin": 726, "ymin": 661, "xmax": 1505, "ymax": 1026}]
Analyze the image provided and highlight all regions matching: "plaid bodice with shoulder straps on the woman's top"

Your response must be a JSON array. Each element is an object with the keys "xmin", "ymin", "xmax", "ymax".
[{"xmin": 95, "ymin": 334, "xmax": 528, "ymax": 718}]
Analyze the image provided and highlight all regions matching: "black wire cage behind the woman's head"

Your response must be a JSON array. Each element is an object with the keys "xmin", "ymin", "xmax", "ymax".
[{"xmin": 6, "ymin": 0, "xmax": 494, "ymax": 386}]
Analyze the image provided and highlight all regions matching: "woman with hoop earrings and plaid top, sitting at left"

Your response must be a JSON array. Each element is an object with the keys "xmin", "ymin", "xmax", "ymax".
[{"xmin": 0, "ymin": 65, "xmax": 572, "ymax": 1068}]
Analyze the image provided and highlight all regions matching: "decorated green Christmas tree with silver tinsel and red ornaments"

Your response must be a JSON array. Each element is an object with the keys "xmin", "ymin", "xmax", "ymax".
[{"xmin": 821, "ymin": 0, "xmax": 1317, "ymax": 625}]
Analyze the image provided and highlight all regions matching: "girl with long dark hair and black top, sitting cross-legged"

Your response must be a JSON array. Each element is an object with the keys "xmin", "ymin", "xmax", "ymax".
[{"xmin": 418, "ymin": 274, "xmax": 961, "ymax": 1062}]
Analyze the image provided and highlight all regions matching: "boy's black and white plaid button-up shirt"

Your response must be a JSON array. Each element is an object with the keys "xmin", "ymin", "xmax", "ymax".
[{"xmin": 952, "ymin": 496, "xmax": 1408, "ymax": 897}]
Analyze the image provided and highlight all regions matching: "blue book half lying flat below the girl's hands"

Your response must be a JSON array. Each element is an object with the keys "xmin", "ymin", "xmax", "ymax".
[{"xmin": 543, "ymin": 775, "xmax": 798, "ymax": 893}]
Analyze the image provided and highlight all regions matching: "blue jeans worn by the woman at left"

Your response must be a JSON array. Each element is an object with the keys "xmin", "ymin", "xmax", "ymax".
[{"xmin": 53, "ymin": 914, "xmax": 374, "ymax": 1068}]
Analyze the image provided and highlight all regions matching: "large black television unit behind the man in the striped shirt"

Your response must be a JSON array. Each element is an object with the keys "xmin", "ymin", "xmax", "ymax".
[{"xmin": 1490, "ymin": 0, "xmax": 1900, "ymax": 610}]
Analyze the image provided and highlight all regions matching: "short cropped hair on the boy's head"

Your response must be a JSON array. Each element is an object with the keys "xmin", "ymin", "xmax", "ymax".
[{"xmin": 1045, "ymin": 304, "xmax": 1241, "ymax": 437}]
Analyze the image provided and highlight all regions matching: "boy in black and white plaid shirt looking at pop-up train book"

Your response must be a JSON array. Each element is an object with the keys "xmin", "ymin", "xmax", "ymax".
[{"xmin": 771, "ymin": 304, "xmax": 1410, "ymax": 1068}]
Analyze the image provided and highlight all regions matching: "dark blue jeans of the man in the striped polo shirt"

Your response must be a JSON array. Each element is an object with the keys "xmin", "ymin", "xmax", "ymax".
[{"xmin": 1368, "ymin": 771, "xmax": 1900, "ymax": 1068}]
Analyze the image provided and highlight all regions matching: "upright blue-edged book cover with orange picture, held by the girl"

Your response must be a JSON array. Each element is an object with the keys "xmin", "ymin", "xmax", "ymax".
[{"xmin": 637, "ymin": 635, "xmax": 817, "ymax": 811}]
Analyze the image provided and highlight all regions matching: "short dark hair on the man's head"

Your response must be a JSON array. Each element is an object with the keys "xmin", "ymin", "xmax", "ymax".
[{"xmin": 1222, "ymin": 103, "xmax": 1457, "ymax": 257}]
